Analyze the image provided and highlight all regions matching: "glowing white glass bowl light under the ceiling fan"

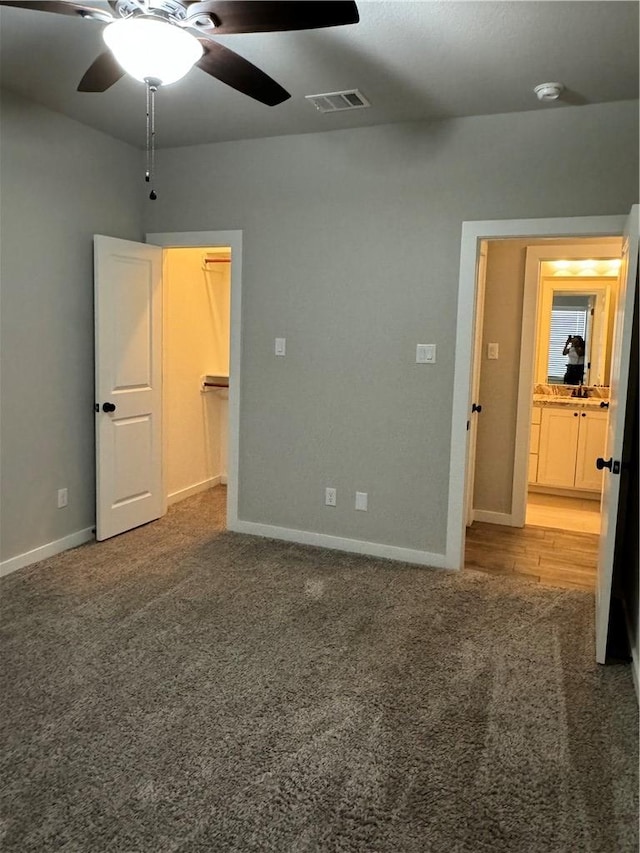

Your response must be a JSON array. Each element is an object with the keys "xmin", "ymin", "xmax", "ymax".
[{"xmin": 102, "ymin": 18, "xmax": 203, "ymax": 86}]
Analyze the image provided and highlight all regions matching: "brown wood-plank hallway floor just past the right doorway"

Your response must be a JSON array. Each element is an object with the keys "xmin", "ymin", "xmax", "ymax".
[{"xmin": 465, "ymin": 521, "xmax": 598, "ymax": 590}]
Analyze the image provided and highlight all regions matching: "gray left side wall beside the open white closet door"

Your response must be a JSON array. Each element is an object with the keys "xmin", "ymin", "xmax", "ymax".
[{"xmin": 0, "ymin": 92, "xmax": 144, "ymax": 559}]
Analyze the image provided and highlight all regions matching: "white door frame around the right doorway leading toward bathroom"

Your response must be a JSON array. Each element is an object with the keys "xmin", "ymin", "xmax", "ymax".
[{"xmin": 445, "ymin": 214, "xmax": 627, "ymax": 569}]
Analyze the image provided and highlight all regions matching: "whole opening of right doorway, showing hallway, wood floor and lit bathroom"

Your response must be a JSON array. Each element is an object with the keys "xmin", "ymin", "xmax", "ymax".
[{"xmin": 465, "ymin": 238, "xmax": 621, "ymax": 589}]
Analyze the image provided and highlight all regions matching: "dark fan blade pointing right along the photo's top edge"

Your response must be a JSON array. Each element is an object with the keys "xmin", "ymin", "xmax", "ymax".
[{"xmin": 187, "ymin": 0, "xmax": 360, "ymax": 35}]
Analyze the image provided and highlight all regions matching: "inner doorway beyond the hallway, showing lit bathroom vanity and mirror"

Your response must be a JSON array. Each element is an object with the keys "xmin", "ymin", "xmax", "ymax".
[{"xmin": 513, "ymin": 238, "xmax": 622, "ymax": 535}]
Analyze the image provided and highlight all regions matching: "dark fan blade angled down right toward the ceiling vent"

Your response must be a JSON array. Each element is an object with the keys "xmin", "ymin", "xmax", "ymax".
[{"xmin": 196, "ymin": 38, "xmax": 291, "ymax": 107}]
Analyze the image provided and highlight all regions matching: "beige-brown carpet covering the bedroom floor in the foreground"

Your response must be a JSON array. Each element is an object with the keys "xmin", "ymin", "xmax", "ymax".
[{"xmin": 0, "ymin": 489, "xmax": 638, "ymax": 853}]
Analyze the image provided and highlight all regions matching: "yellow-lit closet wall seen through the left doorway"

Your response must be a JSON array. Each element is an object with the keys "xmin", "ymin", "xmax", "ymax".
[{"xmin": 164, "ymin": 248, "xmax": 231, "ymax": 503}]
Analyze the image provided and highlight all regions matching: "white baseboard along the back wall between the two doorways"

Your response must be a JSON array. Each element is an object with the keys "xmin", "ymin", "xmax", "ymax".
[{"xmin": 228, "ymin": 520, "xmax": 447, "ymax": 569}]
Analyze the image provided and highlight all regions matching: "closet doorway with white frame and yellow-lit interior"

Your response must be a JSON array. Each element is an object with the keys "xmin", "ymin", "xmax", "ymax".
[{"xmin": 146, "ymin": 226, "xmax": 242, "ymax": 530}]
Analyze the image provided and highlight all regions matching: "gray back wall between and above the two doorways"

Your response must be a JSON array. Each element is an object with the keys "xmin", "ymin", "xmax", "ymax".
[{"xmin": 145, "ymin": 102, "xmax": 638, "ymax": 553}]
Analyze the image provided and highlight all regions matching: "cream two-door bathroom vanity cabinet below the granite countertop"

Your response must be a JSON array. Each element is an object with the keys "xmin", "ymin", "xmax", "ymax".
[{"xmin": 529, "ymin": 406, "xmax": 607, "ymax": 492}]
